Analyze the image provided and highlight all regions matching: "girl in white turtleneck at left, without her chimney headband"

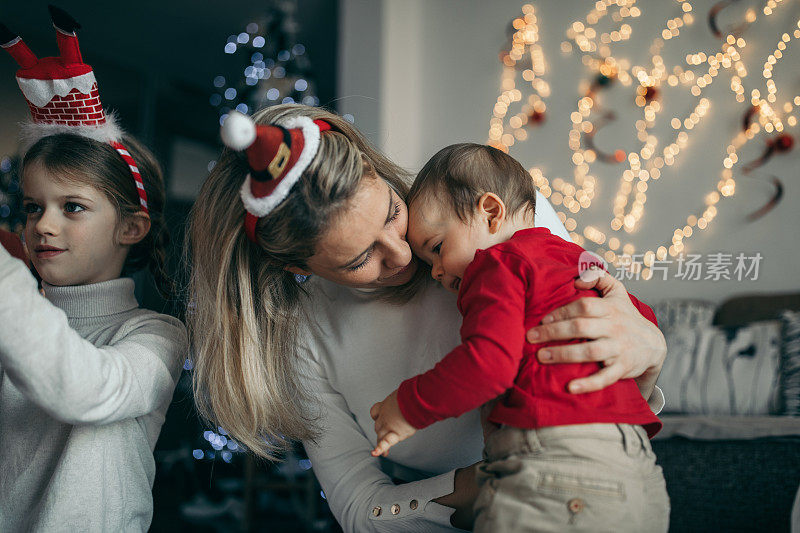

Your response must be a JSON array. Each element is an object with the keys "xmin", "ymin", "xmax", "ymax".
[{"xmin": 0, "ymin": 134, "xmax": 187, "ymax": 531}]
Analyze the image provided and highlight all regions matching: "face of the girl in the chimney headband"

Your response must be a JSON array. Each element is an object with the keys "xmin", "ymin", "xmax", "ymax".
[{"xmin": 22, "ymin": 162, "xmax": 128, "ymax": 285}]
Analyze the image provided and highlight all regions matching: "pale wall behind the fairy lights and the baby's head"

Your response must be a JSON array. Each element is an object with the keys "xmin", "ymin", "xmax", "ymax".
[{"xmin": 339, "ymin": 0, "xmax": 800, "ymax": 301}]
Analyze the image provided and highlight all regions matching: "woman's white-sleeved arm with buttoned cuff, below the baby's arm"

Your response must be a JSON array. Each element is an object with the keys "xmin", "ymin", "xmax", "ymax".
[{"xmin": 301, "ymin": 342, "xmax": 474, "ymax": 533}]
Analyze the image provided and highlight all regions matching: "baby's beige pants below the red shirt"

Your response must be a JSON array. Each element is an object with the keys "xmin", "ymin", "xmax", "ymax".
[{"xmin": 475, "ymin": 424, "xmax": 669, "ymax": 533}]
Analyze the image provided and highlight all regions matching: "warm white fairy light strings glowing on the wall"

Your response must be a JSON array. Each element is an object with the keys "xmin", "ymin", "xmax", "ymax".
[{"xmin": 489, "ymin": 0, "xmax": 800, "ymax": 279}]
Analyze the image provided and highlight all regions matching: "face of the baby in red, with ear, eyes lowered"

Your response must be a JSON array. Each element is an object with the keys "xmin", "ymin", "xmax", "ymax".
[{"xmin": 407, "ymin": 196, "xmax": 496, "ymax": 294}]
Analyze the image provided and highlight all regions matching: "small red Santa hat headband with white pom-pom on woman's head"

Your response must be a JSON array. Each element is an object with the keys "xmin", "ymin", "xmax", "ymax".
[{"xmin": 221, "ymin": 111, "xmax": 331, "ymax": 242}]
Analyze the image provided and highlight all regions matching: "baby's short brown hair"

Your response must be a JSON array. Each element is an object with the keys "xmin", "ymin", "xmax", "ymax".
[{"xmin": 406, "ymin": 143, "xmax": 536, "ymax": 222}]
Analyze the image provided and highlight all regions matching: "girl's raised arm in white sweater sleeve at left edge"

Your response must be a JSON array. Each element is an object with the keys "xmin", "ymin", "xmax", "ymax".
[{"xmin": 0, "ymin": 243, "xmax": 187, "ymax": 424}]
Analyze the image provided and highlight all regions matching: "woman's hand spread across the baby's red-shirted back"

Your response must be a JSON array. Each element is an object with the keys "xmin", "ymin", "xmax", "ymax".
[{"xmin": 527, "ymin": 273, "xmax": 667, "ymax": 398}]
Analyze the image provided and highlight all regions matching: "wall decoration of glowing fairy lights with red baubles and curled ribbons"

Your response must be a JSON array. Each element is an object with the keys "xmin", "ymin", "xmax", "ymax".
[{"xmin": 487, "ymin": 0, "xmax": 800, "ymax": 279}]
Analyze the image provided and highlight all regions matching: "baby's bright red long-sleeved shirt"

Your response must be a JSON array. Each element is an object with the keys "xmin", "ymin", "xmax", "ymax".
[{"xmin": 397, "ymin": 228, "xmax": 661, "ymax": 437}]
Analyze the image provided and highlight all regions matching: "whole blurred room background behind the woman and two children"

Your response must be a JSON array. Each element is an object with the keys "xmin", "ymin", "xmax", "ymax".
[{"xmin": 0, "ymin": 0, "xmax": 800, "ymax": 531}]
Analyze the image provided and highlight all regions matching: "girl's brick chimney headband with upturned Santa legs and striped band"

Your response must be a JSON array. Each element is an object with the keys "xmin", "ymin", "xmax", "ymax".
[{"xmin": 0, "ymin": 6, "xmax": 148, "ymax": 213}]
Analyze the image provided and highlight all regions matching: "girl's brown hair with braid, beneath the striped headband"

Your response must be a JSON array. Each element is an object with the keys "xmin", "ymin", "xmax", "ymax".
[{"xmin": 22, "ymin": 133, "xmax": 174, "ymax": 298}]
